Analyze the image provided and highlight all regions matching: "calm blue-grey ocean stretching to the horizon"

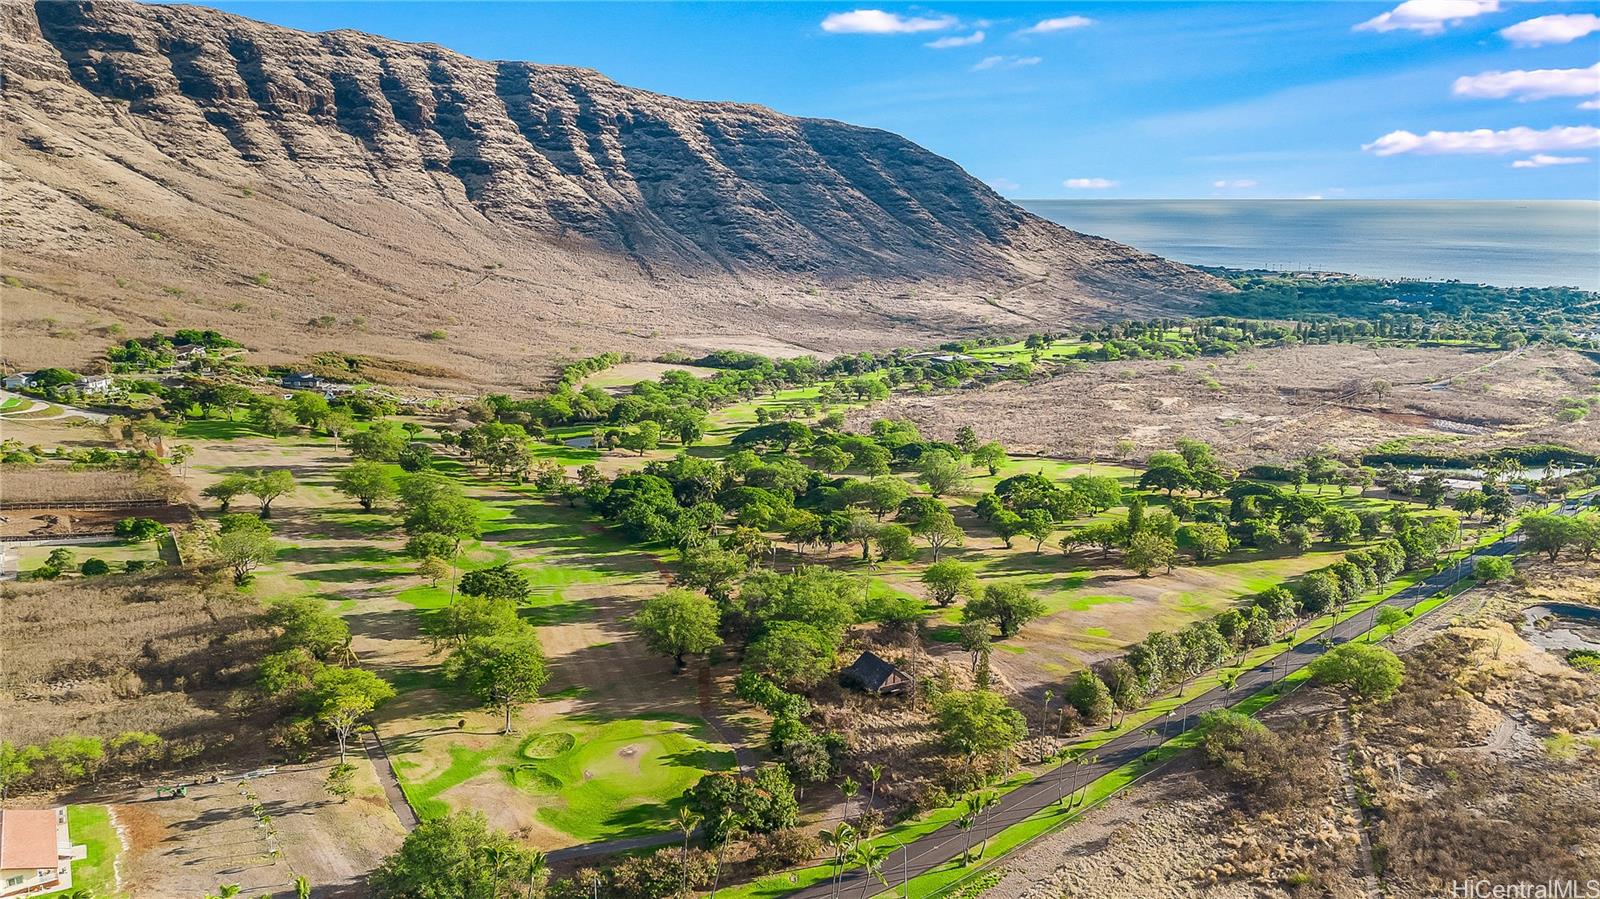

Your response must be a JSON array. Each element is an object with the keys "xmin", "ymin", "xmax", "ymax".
[{"xmin": 1019, "ymin": 200, "xmax": 1600, "ymax": 290}]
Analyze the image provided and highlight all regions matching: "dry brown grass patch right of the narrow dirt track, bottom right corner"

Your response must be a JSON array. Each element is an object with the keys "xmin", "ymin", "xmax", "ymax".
[{"xmin": 1357, "ymin": 561, "xmax": 1600, "ymax": 896}]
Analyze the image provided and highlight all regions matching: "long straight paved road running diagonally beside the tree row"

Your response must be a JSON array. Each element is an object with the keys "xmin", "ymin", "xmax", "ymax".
[{"xmin": 789, "ymin": 521, "xmax": 1548, "ymax": 899}]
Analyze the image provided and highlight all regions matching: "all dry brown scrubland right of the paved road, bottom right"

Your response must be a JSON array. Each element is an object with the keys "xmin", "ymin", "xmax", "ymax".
[{"xmin": 984, "ymin": 561, "xmax": 1600, "ymax": 899}]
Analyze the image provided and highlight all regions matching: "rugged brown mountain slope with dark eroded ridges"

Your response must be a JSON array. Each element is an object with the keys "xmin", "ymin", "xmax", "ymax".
[{"xmin": 0, "ymin": 2, "xmax": 1218, "ymax": 382}]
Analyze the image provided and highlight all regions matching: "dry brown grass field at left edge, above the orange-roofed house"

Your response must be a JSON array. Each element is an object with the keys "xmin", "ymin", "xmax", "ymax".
[{"xmin": 0, "ymin": 571, "xmax": 269, "ymax": 747}]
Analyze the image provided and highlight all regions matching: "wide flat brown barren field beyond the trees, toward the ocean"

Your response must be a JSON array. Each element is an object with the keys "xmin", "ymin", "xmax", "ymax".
[{"xmin": 853, "ymin": 339, "xmax": 1600, "ymax": 462}]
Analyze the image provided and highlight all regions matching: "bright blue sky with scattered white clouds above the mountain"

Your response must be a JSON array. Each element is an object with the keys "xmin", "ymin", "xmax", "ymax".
[{"xmin": 196, "ymin": 0, "xmax": 1600, "ymax": 200}]
